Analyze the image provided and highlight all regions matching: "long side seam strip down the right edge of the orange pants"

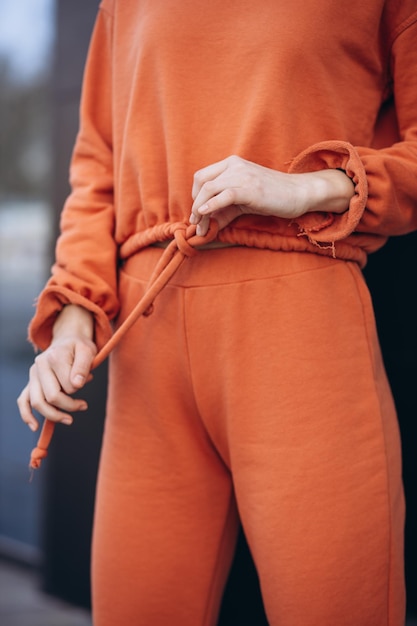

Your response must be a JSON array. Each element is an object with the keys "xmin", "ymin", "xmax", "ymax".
[{"xmin": 346, "ymin": 263, "xmax": 393, "ymax": 626}]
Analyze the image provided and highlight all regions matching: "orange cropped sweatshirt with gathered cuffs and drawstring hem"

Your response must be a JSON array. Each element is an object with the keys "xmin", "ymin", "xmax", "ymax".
[{"xmin": 30, "ymin": 0, "xmax": 417, "ymax": 349}]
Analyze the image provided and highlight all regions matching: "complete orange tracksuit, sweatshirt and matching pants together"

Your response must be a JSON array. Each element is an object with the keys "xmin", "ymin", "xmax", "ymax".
[{"xmin": 30, "ymin": 0, "xmax": 417, "ymax": 626}]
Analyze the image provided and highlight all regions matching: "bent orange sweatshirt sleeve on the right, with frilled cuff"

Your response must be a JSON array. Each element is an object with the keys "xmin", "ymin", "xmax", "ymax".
[{"xmin": 289, "ymin": 11, "xmax": 417, "ymax": 244}]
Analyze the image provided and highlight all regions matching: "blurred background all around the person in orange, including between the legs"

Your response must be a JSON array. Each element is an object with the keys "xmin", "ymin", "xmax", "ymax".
[{"xmin": 0, "ymin": 0, "xmax": 417, "ymax": 626}]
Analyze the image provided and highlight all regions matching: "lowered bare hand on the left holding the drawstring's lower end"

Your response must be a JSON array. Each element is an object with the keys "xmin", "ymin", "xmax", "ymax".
[{"xmin": 17, "ymin": 305, "xmax": 97, "ymax": 431}]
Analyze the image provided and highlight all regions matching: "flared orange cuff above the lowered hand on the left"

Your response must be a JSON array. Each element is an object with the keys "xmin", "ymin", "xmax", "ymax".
[{"xmin": 28, "ymin": 286, "xmax": 113, "ymax": 350}]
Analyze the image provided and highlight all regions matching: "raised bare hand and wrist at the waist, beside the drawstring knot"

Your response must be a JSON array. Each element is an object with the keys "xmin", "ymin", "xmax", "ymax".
[{"xmin": 190, "ymin": 156, "xmax": 354, "ymax": 236}]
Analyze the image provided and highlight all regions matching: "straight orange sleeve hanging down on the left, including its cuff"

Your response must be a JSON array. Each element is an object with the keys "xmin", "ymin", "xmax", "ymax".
[{"xmin": 29, "ymin": 1, "xmax": 119, "ymax": 350}]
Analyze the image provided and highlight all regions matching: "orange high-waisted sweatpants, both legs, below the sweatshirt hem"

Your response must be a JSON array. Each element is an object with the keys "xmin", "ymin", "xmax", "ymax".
[{"xmin": 93, "ymin": 247, "xmax": 404, "ymax": 626}]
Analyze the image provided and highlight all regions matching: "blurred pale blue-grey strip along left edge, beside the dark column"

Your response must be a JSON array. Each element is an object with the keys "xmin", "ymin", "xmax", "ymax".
[{"xmin": 0, "ymin": 0, "xmax": 54, "ymax": 561}]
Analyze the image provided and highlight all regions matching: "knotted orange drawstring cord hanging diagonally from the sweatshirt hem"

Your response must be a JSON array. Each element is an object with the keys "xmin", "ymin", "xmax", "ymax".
[{"xmin": 29, "ymin": 220, "xmax": 218, "ymax": 469}]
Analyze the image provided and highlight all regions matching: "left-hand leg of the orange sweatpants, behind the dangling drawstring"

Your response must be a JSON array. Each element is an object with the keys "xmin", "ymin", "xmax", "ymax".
[{"xmin": 93, "ymin": 264, "xmax": 238, "ymax": 626}]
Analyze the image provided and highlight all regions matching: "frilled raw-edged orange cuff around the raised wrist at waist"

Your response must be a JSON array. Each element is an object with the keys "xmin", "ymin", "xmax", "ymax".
[{"xmin": 288, "ymin": 141, "xmax": 368, "ymax": 245}]
